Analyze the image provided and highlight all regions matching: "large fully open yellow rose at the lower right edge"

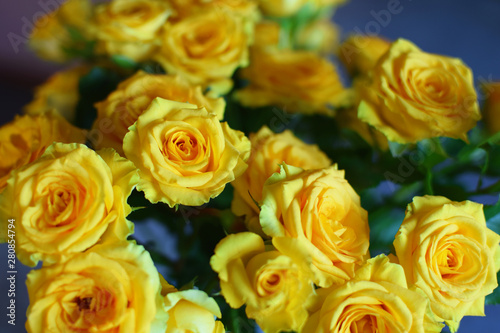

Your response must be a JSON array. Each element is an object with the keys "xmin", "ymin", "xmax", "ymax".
[{"xmin": 394, "ymin": 196, "xmax": 500, "ymax": 330}]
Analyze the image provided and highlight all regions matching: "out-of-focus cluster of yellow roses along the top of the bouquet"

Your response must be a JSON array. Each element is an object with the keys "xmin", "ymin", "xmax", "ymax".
[{"xmin": 27, "ymin": 0, "xmax": 346, "ymax": 114}]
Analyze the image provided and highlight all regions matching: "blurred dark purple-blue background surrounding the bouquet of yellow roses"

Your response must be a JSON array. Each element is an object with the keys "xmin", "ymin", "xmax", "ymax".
[{"xmin": 0, "ymin": 0, "xmax": 500, "ymax": 333}]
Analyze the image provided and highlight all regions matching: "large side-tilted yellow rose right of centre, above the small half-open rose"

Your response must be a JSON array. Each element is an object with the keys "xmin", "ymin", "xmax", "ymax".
[{"xmin": 260, "ymin": 164, "xmax": 370, "ymax": 287}]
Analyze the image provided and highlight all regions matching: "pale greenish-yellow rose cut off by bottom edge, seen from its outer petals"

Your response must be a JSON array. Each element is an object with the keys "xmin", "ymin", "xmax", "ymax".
[{"xmin": 165, "ymin": 289, "xmax": 225, "ymax": 333}]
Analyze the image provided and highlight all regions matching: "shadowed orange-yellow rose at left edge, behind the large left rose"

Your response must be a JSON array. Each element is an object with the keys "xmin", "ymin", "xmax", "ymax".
[{"xmin": 0, "ymin": 112, "xmax": 86, "ymax": 192}]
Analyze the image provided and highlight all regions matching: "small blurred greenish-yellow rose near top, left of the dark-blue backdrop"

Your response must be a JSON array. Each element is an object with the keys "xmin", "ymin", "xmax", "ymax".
[{"xmin": 297, "ymin": 20, "xmax": 340, "ymax": 54}]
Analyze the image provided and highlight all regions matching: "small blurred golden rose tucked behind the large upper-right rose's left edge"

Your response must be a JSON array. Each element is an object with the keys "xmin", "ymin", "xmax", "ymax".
[{"xmin": 339, "ymin": 35, "xmax": 391, "ymax": 75}]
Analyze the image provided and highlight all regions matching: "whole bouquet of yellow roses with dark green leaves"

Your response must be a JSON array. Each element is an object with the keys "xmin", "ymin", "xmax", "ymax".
[{"xmin": 0, "ymin": 0, "xmax": 500, "ymax": 333}]
